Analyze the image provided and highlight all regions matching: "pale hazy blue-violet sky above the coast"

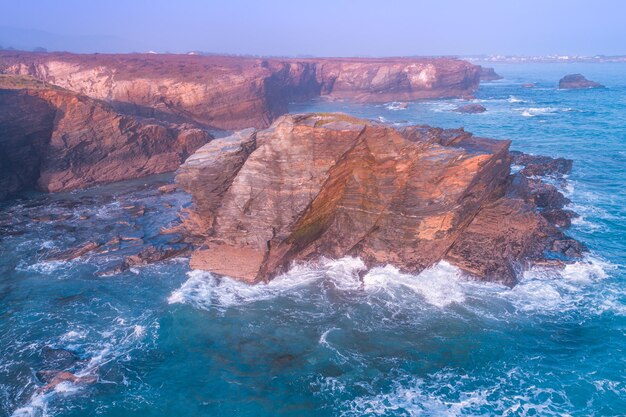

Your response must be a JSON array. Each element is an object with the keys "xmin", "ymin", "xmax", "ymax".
[{"xmin": 0, "ymin": 0, "xmax": 626, "ymax": 56}]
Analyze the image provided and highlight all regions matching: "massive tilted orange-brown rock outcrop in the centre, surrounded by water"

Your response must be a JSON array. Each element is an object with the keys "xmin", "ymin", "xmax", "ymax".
[{"xmin": 177, "ymin": 114, "xmax": 582, "ymax": 285}]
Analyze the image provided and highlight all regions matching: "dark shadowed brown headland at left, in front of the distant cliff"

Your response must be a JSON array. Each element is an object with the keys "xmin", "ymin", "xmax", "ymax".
[{"xmin": 0, "ymin": 76, "xmax": 211, "ymax": 199}]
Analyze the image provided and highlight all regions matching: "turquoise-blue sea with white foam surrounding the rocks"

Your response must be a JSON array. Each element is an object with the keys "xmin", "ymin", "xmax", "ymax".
[{"xmin": 0, "ymin": 64, "xmax": 626, "ymax": 417}]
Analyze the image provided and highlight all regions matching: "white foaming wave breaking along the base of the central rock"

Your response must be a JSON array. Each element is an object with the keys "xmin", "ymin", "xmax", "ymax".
[{"xmin": 167, "ymin": 252, "xmax": 621, "ymax": 315}]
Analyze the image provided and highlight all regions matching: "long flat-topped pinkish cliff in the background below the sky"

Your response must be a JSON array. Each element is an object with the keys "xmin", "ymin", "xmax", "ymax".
[{"xmin": 0, "ymin": 51, "xmax": 479, "ymax": 130}]
